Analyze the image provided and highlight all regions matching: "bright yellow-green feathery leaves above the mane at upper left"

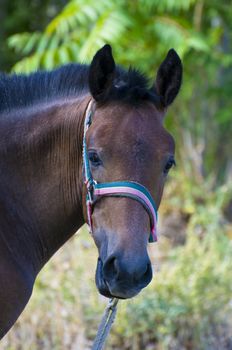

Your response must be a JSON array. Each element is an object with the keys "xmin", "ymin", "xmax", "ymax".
[{"xmin": 9, "ymin": 0, "xmax": 130, "ymax": 72}]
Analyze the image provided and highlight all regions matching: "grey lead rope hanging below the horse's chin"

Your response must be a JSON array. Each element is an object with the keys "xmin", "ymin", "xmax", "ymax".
[{"xmin": 92, "ymin": 298, "xmax": 119, "ymax": 350}]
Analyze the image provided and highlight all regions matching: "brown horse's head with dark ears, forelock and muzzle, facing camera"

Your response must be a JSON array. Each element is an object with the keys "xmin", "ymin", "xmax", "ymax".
[{"xmin": 83, "ymin": 45, "xmax": 182, "ymax": 298}]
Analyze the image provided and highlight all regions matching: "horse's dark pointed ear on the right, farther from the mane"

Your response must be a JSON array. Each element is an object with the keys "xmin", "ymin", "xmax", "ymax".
[{"xmin": 155, "ymin": 49, "xmax": 182, "ymax": 107}]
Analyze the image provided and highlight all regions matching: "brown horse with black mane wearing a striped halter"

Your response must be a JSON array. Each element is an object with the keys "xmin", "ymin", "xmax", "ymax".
[{"xmin": 0, "ymin": 45, "xmax": 182, "ymax": 338}]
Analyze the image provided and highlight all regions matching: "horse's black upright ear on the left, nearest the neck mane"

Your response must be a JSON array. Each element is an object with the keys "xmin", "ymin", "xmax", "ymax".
[{"xmin": 89, "ymin": 45, "xmax": 115, "ymax": 101}]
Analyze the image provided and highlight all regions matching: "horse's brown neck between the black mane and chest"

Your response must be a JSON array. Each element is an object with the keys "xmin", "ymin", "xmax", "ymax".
[{"xmin": 0, "ymin": 98, "xmax": 88, "ymax": 274}]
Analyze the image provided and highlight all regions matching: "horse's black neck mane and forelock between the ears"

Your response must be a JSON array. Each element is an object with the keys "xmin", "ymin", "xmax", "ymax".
[{"xmin": 0, "ymin": 64, "xmax": 159, "ymax": 112}]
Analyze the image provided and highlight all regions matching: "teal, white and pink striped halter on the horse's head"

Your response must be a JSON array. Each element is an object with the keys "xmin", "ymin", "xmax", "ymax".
[{"xmin": 83, "ymin": 101, "xmax": 158, "ymax": 242}]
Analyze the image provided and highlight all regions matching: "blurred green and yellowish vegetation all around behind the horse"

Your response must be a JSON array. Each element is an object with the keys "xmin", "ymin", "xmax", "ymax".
[{"xmin": 0, "ymin": 0, "xmax": 232, "ymax": 350}]
